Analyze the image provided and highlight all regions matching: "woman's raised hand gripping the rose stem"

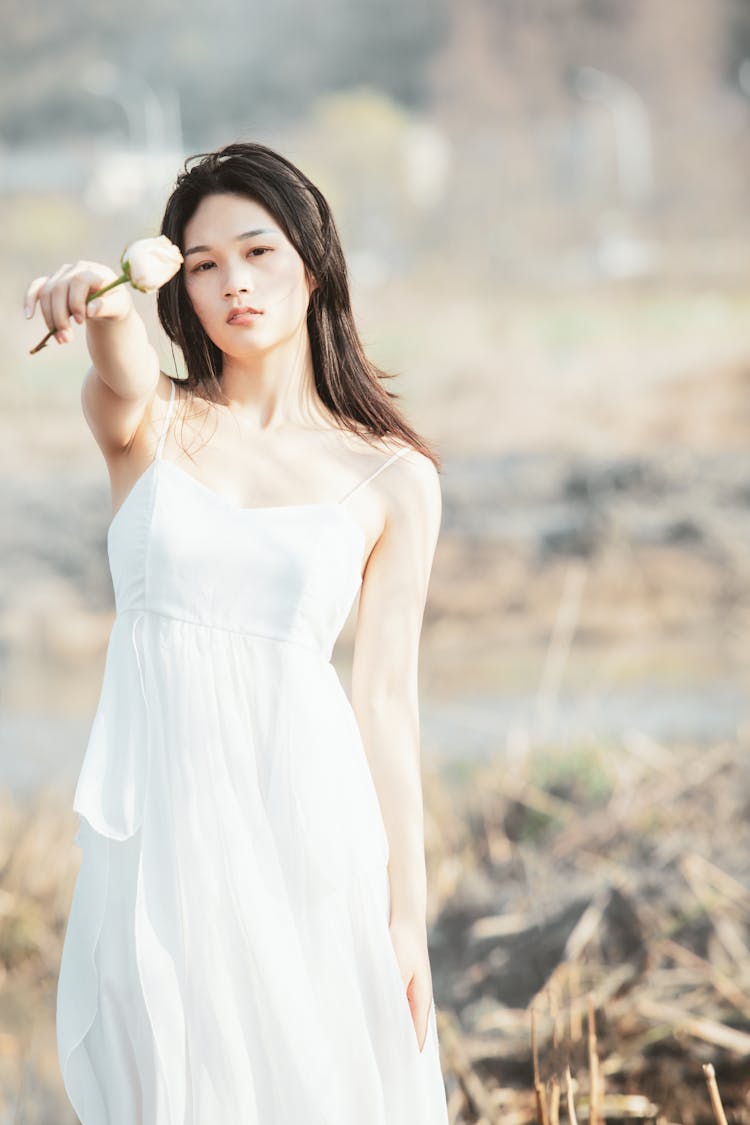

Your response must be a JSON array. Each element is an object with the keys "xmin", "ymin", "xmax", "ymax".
[{"xmin": 24, "ymin": 262, "xmax": 133, "ymax": 343}]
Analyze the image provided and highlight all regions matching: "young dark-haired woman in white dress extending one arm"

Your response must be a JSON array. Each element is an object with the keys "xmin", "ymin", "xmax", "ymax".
[{"xmin": 27, "ymin": 143, "xmax": 448, "ymax": 1125}]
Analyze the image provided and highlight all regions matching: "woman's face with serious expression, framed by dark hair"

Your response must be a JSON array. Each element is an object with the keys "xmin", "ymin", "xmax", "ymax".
[{"xmin": 182, "ymin": 192, "xmax": 314, "ymax": 357}]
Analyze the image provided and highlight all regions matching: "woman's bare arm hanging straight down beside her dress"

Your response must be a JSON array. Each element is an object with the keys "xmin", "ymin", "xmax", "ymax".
[{"xmin": 352, "ymin": 451, "xmax": 442, "ymax": 1050}]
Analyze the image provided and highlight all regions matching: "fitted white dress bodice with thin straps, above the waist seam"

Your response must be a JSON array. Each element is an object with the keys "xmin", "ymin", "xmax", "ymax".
[{"xmin": 107, "ymin": 383, "xmax": 410, "ymax": 659}]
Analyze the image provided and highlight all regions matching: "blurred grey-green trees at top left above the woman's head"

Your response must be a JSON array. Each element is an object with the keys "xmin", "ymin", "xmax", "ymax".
[{"xmin": 0, "ymin": 0, "xmax": 450, "ymax": 147}]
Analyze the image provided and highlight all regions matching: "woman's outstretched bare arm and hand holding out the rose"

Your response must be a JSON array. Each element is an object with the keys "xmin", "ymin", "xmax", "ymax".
[{"xmin": 24, "ymin": 262, "xmax": 160, "ymax": 457}]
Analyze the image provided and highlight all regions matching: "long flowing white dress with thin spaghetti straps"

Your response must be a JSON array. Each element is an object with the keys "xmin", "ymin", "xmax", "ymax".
[{"xmin": 56, "ymin": 384, "xmax": 448, "ymax": 1125}]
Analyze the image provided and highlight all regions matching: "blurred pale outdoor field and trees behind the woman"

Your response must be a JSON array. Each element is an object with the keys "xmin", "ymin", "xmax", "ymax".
[{"xmin": 0, "ymin": 0, "xmax": 750, "ymax": 1125}]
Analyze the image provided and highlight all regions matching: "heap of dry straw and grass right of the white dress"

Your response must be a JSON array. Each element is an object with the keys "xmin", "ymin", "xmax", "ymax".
[{"xmin": 425, "ymin": 736, "xmax": 750, "ymax": 1125}]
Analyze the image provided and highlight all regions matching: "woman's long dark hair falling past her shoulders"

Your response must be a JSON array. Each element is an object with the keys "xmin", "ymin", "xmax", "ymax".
[{"xmin": 156, "ymin": 142, "xmax": 441, "ymax": 471}]
